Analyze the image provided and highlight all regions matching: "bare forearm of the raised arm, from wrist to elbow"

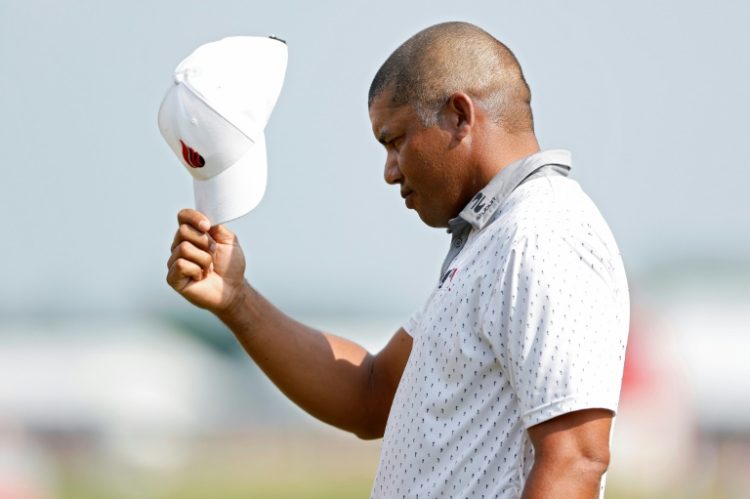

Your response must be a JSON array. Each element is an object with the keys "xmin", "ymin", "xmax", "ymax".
[{"xmin": 217, "ymin": 285, "xmax": 378, "ymax": 437}]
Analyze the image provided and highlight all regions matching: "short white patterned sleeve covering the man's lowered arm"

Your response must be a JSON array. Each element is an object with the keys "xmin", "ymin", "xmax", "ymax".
[{"xmin": 484, "ymin": 225, "xmax": 629, "ymax": 428}]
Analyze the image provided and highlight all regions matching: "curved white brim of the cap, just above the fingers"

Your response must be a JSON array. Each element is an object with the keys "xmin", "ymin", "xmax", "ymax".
[{"xmin": 193, "ymin": 135, "xmax": 268, "ymax": 225}]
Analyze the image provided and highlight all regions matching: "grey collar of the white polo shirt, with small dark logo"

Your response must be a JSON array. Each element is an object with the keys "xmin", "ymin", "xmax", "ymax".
[{"xmin": 448, "ymin": 149, "xmax": 571, "ymax": 233}]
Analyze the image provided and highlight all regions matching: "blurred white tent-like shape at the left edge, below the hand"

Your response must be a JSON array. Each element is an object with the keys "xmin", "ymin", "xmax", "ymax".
[{"xmin": 0, "ymin": 321, "xmax": 253, "ymax": 467}]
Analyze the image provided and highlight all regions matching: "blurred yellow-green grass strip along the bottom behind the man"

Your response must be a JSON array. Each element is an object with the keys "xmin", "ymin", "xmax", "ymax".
[{"xmin": 44, "ymin": 431, "xmax": 750, "ymax": 499}]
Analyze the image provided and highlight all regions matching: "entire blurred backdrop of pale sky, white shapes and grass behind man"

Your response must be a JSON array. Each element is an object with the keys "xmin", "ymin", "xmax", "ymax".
[{"xmin": 0, "ymin": 0, "xmax": 750, "ymax": 499}]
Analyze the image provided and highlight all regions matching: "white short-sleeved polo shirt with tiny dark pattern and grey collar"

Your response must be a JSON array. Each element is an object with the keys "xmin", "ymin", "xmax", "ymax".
[{"xmin": 372, "ymin": 150, "xmax": 629, "ymax": 499}]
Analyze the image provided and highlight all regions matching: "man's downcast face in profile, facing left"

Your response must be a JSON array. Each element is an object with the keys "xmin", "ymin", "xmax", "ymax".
[{"xmin": 370, "ymin": 91, "xmax": 473, "ymax": 227}]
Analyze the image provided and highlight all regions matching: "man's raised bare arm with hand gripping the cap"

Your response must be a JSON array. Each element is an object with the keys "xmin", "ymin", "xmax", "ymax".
[{"xmin": 167, "ymin": 210, "xmax": 411, "ymax": 438}]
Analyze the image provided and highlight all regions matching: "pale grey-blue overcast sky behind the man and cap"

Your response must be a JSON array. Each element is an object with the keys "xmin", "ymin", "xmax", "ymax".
[{"xmin": 0, "ymin": 0, "xmax": 750, "ymax": 316}]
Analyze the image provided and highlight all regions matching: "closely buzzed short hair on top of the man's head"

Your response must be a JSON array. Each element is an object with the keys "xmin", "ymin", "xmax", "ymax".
[{"xmin": 368, "ymin": 22, "xmax": 534, "ymax": 133}]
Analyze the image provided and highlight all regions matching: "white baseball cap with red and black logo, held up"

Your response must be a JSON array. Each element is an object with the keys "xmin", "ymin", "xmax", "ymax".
[{"xmin": 159, "ymin": 36, "xmax": 287, "ymax": 225}]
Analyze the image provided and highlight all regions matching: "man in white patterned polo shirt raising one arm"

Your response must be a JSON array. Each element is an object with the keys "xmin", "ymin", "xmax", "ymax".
[{"xmin": 167, "ymin": 23, "xmax": 629, "ymax": 499}]
